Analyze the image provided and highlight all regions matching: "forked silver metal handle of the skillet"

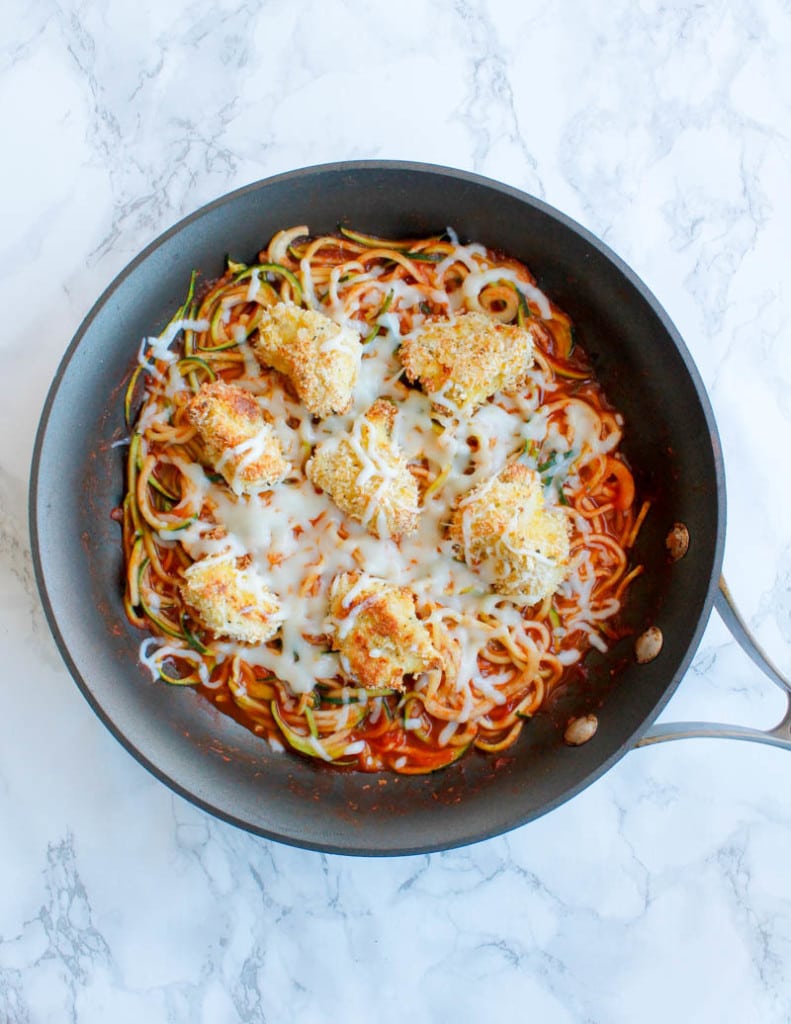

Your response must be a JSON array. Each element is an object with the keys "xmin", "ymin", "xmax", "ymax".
[{"xmin": 635, "ymin": 578, "xmax": 791, "ymax": 751}]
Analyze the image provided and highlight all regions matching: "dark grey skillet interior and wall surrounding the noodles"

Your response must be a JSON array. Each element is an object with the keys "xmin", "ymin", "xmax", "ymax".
[{"xmin": 30, "ymin": 162, "xmax": 788, "ymax": 855}]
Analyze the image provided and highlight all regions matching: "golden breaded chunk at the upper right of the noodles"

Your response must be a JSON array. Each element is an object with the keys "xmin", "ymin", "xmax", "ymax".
[{"xmin": 400, "ymin": 312, "xmax": 534, "ymax": 415}]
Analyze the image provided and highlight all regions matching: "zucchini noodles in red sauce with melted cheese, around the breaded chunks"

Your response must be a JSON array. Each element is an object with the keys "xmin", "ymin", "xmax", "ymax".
[{"xmin": 116, "ymin": 227, "xmax": 649, "ymax": 774}]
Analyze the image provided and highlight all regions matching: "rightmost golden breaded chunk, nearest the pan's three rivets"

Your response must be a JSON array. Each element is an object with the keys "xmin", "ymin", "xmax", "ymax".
[{"xmin": 450, "ymin": 463, "xmax": 570, "ymax": 604}]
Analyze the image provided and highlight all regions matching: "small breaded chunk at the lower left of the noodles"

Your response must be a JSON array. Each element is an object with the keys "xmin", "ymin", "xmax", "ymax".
[{"xmin": 180, "ymin": 553, "xmax": 283, "ymax": 644}]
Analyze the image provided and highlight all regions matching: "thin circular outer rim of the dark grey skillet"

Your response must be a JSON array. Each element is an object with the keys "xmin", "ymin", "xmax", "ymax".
[{"xmin": 28, "ymin": 160, "xmax": 726, "ymax": 856}]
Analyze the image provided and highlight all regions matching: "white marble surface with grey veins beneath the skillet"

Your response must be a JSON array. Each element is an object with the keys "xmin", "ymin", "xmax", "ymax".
[{"xmin": 0, "ymin": 0, "xmax": 791, "ymax": 1024}]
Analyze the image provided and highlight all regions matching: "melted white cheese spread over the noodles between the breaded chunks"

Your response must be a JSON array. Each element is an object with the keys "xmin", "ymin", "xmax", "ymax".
[{"xmin": 141, "ymin": 236, "xmax": 621, "ymax": 696}]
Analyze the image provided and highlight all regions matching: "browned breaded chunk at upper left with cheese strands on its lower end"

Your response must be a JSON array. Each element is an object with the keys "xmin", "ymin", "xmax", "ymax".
[{"xmin": 186, "ymin": 381, "xmax": 291, "ymax": 495}]
